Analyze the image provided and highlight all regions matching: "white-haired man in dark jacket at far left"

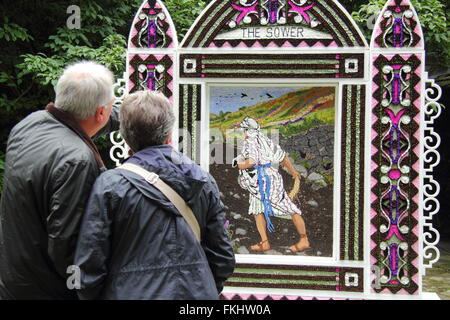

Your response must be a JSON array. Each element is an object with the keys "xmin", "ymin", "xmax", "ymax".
[{"xmin": 0, "ymin": 61, "xmax": 119, "ymax": 299}]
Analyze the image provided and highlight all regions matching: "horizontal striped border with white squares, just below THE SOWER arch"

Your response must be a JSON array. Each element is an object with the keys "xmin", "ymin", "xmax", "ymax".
[{"xmin": 179, "ymin": 53, "xmax": 365, "ymax": 79}]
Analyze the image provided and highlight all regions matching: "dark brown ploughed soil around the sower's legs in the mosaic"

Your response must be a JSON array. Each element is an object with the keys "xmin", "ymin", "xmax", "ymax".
[{"xmin": 210, "ymin": 164, "xmax": 333, "ymax": 257}]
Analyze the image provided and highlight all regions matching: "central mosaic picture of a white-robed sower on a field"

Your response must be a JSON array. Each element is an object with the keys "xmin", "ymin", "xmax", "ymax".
[{"xmin": 209, "ymin": 85, "xmax": 336, "ymax": 257}]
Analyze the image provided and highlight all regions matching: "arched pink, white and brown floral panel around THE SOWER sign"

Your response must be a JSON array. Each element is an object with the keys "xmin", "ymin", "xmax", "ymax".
[{"xmin": 182, "ymin": 0, "xmax": 367, "ymax": 48}]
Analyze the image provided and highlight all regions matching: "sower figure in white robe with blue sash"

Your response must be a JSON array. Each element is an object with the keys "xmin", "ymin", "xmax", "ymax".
[{"xmin": 233, "ymin": 117, "xmax": 310, "ymax": 253}]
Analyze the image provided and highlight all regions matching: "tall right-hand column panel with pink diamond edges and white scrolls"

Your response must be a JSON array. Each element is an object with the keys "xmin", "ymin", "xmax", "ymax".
[{"xmin": 371, "ymin": 54, "xmax": 423, "ymax": 294}]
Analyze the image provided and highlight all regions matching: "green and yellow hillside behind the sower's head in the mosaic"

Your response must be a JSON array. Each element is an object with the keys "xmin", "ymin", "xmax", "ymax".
[{"xmin": 210, "ymin": 87, "xmax": 335, "ymax": 136}]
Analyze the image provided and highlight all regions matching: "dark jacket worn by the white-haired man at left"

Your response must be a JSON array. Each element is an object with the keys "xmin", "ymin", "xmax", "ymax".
[{"xmin": 0, "ymin": 108, "xmax": 119, "ymax": 299}]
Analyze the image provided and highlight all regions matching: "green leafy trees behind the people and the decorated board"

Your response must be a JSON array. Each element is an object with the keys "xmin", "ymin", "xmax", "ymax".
[{"xmin": 0, "ymin": 0, "xmax": 450, "ymax": 193}]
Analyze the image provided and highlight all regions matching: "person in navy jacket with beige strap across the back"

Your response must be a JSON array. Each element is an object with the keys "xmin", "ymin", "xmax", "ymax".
[{"xmin": 75, "ymin": 91, "xmax": 235, "ymax": 300}]
